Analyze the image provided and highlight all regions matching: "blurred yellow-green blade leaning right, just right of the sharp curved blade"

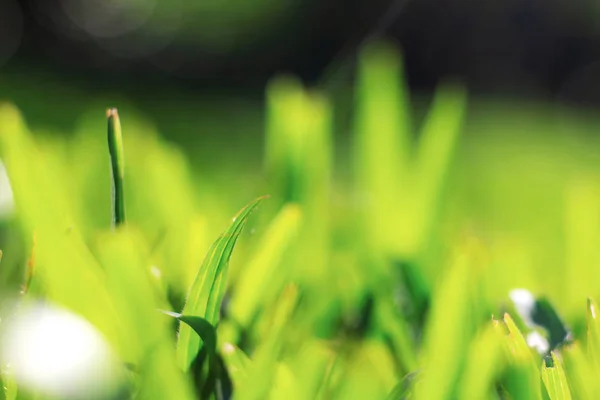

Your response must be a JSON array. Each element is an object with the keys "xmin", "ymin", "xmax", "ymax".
[{"xmin": 230, "ymin": 204, "xmax": 302, "ymax": 327}]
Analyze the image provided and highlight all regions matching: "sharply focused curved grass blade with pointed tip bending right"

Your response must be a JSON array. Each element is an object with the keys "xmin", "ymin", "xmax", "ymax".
[{"xmin": 177, "ymin": 197, "xmax": 264, "ymax": 371}]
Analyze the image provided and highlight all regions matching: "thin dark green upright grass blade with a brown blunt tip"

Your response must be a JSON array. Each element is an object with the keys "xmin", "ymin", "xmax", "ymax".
[{"xmin": 106, "ymin": 108, "xmax": 125, "ymax": 226}]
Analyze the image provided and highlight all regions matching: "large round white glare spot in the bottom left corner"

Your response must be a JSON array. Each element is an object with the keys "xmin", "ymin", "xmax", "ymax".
[{"xmin": 1, "ymin": 305, "xmax": 123, "ymax": 399}]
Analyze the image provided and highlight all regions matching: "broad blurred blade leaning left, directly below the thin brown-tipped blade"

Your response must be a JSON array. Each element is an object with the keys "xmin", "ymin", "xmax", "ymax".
[{"xmin": 98, "ymin": 227, "xmax": 194, "ymax": 400}]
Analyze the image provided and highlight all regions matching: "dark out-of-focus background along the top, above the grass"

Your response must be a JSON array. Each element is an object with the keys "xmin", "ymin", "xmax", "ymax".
[{"xmin": 0, "ymin": 0, "xmax": 600, "ymax": 106}]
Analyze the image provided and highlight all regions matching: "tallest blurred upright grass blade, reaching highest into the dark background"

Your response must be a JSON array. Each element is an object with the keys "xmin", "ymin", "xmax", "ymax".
[{"xmin": 353, "ymin": 43, "xmax": 410, "ymax": 250}]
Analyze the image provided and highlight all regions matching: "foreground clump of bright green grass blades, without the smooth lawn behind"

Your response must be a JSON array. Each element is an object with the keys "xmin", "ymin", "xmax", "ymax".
[{"xmin": 0, "ymin": 41, "xmax": 600, "ymax": 400}]
